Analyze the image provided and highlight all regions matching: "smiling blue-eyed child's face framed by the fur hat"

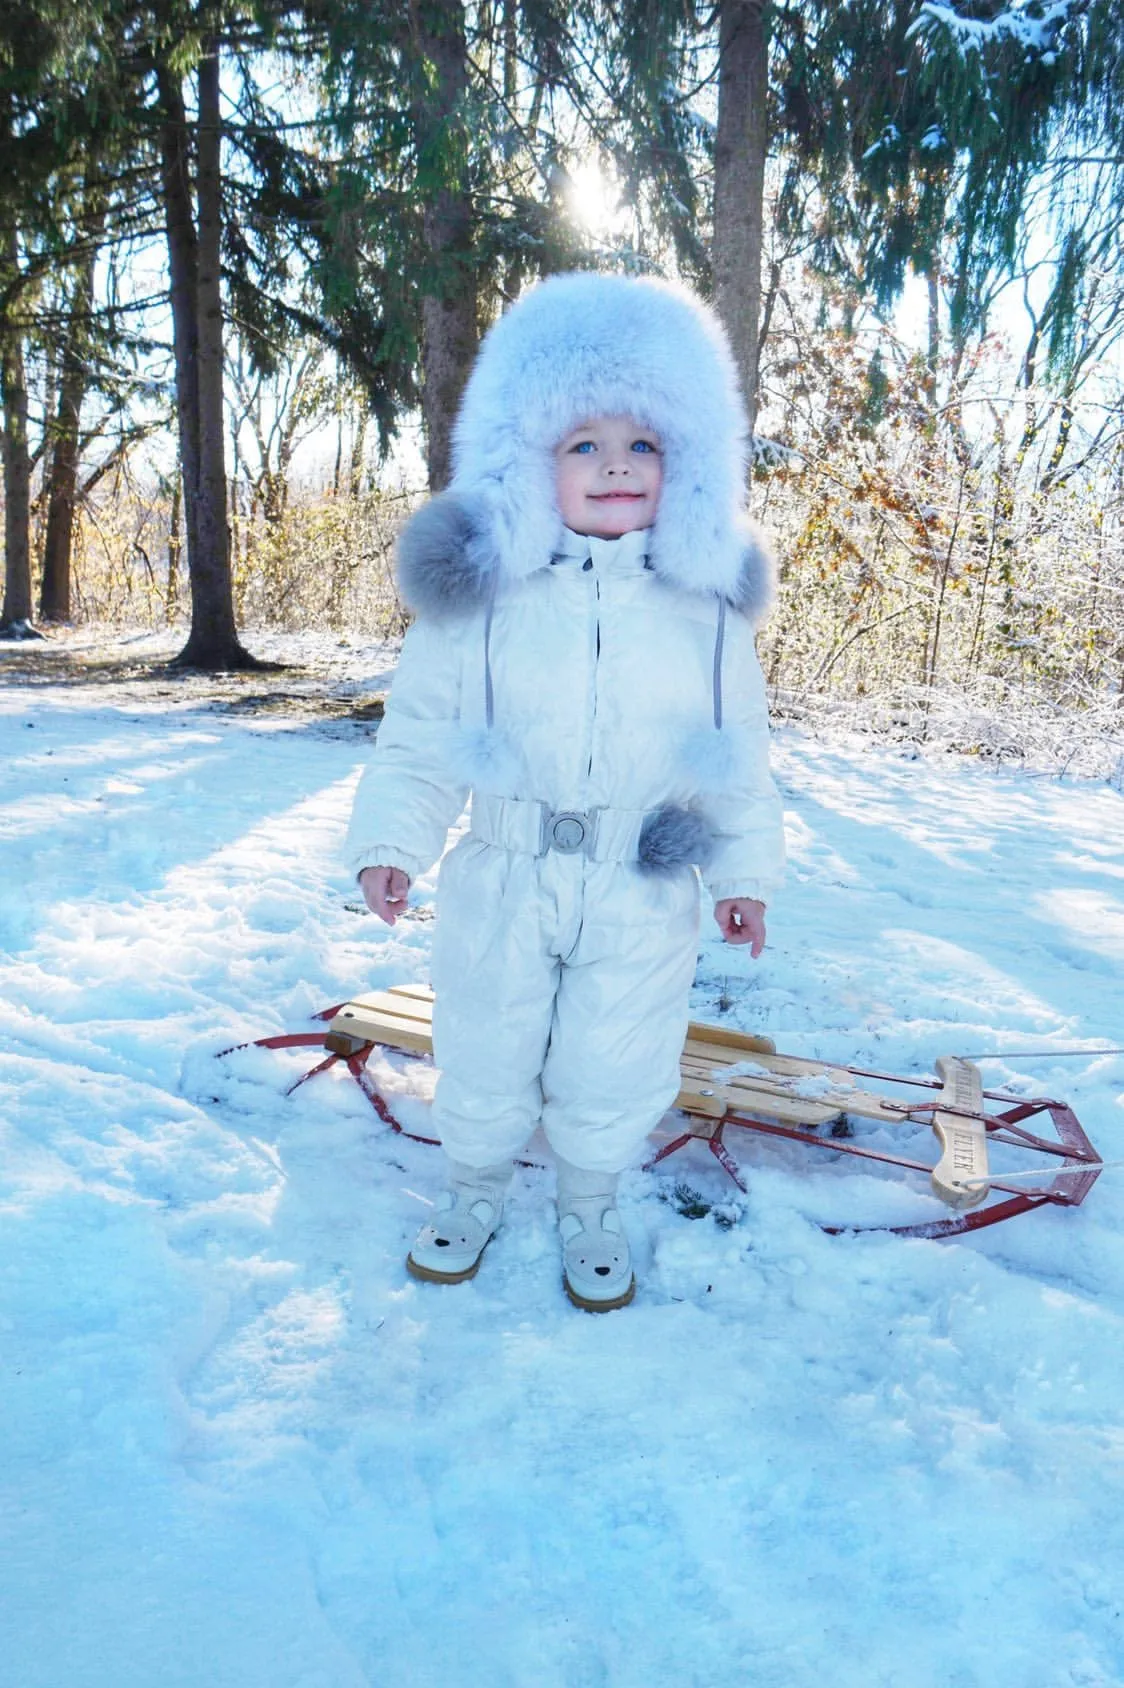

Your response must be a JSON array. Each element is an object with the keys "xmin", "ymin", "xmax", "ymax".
[{"xmin": 554, "ymin": 417, "xmax": 663, "ymax": 538}]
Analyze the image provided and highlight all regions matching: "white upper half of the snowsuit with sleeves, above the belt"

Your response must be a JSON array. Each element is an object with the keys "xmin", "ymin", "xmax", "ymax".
[{"xmin": 348, "ymin": 516, "xmax": 783, "ymax": 901}]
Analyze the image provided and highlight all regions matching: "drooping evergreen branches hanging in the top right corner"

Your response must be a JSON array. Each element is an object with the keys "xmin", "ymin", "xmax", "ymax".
[{"xmin": 776, "ymin": 0, "xmax": 1124, "ymax": 370}]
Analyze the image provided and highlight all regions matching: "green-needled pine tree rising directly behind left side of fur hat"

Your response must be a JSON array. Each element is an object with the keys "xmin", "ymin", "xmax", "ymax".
[{"xmin": 312, "ymin": 0, "xmax": 614, "ymax": 488}]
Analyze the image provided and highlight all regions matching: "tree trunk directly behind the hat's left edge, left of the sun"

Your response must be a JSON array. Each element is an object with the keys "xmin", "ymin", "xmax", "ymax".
[{"xmin": 410, "ymin": 0, "xmax": 478, "ymax": 491}]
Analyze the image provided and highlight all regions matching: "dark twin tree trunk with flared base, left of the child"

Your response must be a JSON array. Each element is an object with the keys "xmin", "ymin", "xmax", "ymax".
[{"xmin": 157, "ymin": 41, "xmax": 255, "ymax": 668}]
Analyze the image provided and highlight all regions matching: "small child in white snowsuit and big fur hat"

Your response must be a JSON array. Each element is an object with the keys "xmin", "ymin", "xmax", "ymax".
[{"xmin": 340, "ymin": 275, "xmax": 783, "ymax": 1312}]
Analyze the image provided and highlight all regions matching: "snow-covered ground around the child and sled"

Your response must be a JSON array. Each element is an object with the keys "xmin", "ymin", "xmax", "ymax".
[{"xmin": 0, "ymin": 634, "xmax": 1124, "ymax": 1688}]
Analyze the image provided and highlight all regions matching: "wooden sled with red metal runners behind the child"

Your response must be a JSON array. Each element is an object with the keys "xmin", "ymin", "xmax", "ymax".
[{"xmin": 221, "ymin": 986, "xmax": 1102, "ymax": 1237}]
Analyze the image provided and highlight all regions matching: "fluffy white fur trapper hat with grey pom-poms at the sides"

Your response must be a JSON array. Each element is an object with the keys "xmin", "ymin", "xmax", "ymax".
[{"xmin": 398, "ymin": 273, "xmax": 773, "ymax": 619}]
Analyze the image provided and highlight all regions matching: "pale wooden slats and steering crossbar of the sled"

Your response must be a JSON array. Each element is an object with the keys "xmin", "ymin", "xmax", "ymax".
[{"xmin": 326, "ymin": 986, "xmax": 989, "ymax": 1209}]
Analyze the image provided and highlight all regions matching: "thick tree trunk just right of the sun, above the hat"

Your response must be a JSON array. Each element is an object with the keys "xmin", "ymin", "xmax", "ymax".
[{"xmin": 712, "ymin": 0, "xmax": 770, "ymax": 442}]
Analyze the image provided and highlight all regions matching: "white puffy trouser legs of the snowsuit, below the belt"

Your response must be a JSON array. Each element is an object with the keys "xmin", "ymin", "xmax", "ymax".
[{"xmin": 432, "ymin": 834, "xmax": 699, "ymax": 1173}]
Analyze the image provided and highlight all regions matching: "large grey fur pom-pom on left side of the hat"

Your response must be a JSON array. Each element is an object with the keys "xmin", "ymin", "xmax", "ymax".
[{"xmin": 398, "ymin": 493, "xmax": 494, "ymax": 621}]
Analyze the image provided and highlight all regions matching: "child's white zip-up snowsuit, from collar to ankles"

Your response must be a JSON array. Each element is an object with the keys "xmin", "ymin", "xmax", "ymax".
[{"xmin": 349, "ymin": 519, "xmax": 781, "ymax": 1171}]
